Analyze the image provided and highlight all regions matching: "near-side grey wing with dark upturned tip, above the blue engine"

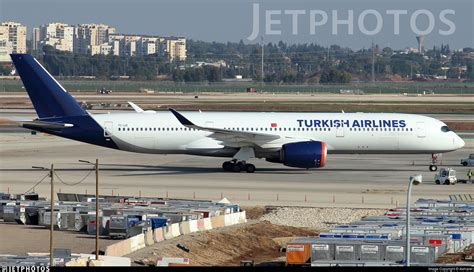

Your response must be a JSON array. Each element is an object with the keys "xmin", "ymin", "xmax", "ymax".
[{"xmin": 169, "ymin": 108, "xmax": 281, "ymax": 146}]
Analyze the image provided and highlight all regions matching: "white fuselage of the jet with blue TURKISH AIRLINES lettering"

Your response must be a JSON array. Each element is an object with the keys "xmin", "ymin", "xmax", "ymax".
[{"xmin": 92, "ymin": 112, "xmax": 464, "ymax": 157}]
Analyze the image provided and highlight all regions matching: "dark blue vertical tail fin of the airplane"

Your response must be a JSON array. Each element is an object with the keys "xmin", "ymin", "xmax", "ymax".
[{"xmin": 11, "ymin": 54, "xmax": 87, "ymax": 118}]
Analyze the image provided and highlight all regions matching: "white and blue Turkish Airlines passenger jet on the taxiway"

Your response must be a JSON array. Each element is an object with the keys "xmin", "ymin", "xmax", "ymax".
[{"xmin": 11, "ymin": 54, "xmax": 464, "ymax": 173}]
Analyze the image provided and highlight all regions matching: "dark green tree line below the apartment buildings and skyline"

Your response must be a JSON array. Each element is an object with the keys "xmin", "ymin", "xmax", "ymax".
[{"xmin": 16, "ymin": 40, "xmax": 474, "ymax": 84}]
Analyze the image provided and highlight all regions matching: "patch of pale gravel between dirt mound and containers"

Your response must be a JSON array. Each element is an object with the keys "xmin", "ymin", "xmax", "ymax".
[{"xmin": 260, "ymin": 207, "xmax": 387, "ymax": 231}]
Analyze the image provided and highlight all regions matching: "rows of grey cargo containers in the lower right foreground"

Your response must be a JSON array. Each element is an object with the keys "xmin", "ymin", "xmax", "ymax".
[{"xmin": 287, "ymin": 199, "xmax": 474, "ymax": 266}]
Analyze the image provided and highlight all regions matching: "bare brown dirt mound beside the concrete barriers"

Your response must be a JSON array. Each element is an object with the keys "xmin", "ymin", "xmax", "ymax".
[{"xmin": 128, "ymin": 221, "xmax": 318, "ymax": 266}]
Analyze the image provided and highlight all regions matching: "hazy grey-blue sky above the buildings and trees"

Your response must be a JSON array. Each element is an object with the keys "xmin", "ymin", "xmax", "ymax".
[{"xmin": 0, "ymin": 0, "xmax": 474, "ymax": 50}]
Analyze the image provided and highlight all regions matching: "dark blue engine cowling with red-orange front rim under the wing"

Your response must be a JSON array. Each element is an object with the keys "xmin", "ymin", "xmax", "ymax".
[{"xmin": 280, "ymin": 141, "xmax": 327, "ymax": 168}]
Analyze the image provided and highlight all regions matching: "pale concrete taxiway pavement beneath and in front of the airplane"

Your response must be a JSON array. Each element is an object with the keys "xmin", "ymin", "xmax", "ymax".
[{"xmin": 0, "ymin": 133, "xmax": 474, "ymax": 208}]
